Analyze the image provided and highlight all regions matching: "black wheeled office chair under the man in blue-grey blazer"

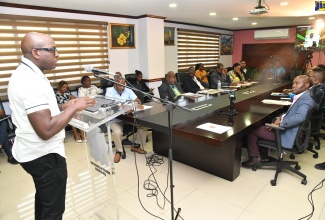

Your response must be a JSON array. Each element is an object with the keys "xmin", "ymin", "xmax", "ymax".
[{"xmin": 252, "ymin": 106, "xmax": 317, "ymax": 186}]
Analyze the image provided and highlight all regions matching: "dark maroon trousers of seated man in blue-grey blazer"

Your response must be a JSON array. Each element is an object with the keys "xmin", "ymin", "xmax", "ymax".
[{"xmin": 247, "ymin": 125, "xmax": 275, "ymax": 157}]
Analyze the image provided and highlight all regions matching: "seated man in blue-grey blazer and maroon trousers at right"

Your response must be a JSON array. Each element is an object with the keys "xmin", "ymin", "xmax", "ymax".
[{"xmin": 242, "ymin": 75, "xmax": 315, "ymax": 167}]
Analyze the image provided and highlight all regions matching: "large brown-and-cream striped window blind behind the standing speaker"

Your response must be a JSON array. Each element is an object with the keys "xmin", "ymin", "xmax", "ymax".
[{"xmin": 0, "ymin": 16, "xmax": 109, "ymax": 100}]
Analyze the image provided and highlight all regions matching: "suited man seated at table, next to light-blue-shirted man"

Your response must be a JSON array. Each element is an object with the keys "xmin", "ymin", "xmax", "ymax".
[{"xmin": 159, "ymin": 71, "xmax": 183, "ymax": 102}]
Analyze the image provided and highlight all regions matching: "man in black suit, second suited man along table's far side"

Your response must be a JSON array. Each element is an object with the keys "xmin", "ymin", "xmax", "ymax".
[{"xmin": 182, "ymin": 66, "xmax": 208, "ymax": 93}]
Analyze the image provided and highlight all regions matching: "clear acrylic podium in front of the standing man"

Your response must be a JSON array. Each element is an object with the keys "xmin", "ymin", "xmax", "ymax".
[{"xmin": 67, "ymin": 101, "xmax": 137, "ymax": 220}]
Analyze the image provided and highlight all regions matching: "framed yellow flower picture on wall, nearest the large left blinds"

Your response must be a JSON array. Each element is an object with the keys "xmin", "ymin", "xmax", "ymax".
[{"xmin": 109, "ymin": 24, "xmax": 135, "ymax": 49}]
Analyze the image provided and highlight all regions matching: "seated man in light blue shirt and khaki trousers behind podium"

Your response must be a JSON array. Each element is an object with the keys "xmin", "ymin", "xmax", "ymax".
[{"xmin": 105, "ymin": 75, "xmax": 147, "ymax": 163}]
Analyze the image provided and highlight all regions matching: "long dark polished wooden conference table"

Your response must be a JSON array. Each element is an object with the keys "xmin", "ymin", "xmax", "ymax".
[{"xmin": 120, "ymin": 82, "xmax": 291, "ymax": 181}]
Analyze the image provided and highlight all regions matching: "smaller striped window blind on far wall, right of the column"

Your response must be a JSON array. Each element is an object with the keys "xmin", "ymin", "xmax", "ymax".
[{"xmin": 177, "ymin": 28, "xmax": 220, "ymax": 72}]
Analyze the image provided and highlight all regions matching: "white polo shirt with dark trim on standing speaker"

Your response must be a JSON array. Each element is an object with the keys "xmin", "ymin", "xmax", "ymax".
[{"xmin": 8, "ymin": 57, "xmax": 65, "ymax": 162}]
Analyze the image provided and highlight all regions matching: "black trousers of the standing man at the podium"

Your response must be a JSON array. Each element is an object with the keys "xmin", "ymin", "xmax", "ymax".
[{"xmin": 20, "ymin": 153, "xmax": 68, "ymax": 220}]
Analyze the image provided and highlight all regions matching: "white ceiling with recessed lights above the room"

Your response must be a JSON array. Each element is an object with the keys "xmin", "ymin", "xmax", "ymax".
[{"xmin": 2, "ymin": 0, "xmax": 325, "ymax": 30}]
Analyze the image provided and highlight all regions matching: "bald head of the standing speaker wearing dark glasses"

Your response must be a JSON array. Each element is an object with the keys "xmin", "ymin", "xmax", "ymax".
[{"xmin": 21, "ymin": 32, "xmax": 59, "ymax": 71}]
